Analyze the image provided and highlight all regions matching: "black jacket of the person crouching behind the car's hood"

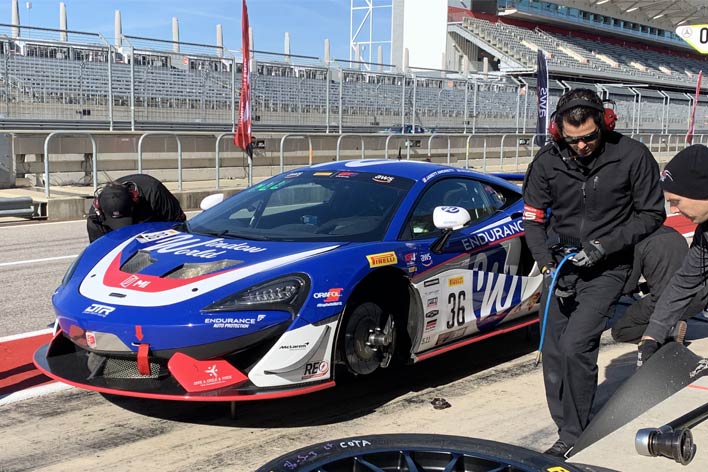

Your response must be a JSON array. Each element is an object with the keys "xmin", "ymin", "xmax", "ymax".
[{"xmin": 87, "ymin": 174, "xmax": 186, "ymax": 242}]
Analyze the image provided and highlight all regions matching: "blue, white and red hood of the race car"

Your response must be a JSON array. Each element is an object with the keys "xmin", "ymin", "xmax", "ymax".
[{"xmin": 74, "ymin": 229, "xmax": 339, "ymax": 308}]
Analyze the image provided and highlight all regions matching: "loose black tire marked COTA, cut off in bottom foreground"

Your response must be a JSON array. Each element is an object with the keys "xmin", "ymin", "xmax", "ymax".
[{"xmin": 256, "ymin": 434, "xmax": 587, "ymax": 472}]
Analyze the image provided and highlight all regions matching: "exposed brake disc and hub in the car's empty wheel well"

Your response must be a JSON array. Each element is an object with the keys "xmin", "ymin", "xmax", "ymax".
[{"xmin": 342, "ymin": 302, "xmax": 396, "ymax": 375}]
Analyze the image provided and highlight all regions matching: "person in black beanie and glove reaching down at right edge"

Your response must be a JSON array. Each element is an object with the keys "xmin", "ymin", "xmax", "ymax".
[{"xmin": 637, "ymin": 144, "xmax": 708, "ymax": 366}]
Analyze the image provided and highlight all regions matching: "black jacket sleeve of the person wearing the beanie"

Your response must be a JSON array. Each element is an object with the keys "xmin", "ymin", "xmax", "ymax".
[{"xmin": 644, "ymin": 222, "xmax": 708, "ymax": 343}]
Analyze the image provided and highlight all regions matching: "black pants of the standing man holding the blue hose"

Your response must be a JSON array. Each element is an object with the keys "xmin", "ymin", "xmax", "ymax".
[{"xmin": 542, "ymin": 263, "xmax": 630, "ymax": 445}]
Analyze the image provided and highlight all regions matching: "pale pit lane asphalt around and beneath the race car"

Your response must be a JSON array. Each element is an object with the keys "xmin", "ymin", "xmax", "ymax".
[{"xmin": 0, "ymin": 216, "xmax": 708, "ymax": 472}]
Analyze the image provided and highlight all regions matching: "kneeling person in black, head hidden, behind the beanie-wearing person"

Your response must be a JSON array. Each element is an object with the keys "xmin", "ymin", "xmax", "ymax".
[{"xmin": 612, "ymin": 225, "xmax": 708, "ymax": 344}]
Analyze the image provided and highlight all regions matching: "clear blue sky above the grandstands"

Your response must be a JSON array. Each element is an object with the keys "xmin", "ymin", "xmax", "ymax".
[{"xmin": 0, "ymin": 0, "xmax": 390, "ymax": 59}]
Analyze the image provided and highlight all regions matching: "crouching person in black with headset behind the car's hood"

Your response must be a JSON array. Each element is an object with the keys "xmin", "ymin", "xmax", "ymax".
[{"xmin": 86, "ymin": 174, "xmax": 186, "ymax": 242}]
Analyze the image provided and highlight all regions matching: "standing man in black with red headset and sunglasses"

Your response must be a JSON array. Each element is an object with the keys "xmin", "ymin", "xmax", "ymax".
[{"xmin": 523, "ymin": 89, "xmax": 666, "ymax": 457}]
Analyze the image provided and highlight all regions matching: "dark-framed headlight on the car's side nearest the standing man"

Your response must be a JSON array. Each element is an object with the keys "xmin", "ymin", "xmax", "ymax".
[{"xmin": 202, "ymin": 274, "xmax": 310, "ymax": 314}]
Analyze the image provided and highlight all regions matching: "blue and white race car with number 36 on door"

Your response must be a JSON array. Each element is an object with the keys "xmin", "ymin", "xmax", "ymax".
[{"xmin": 34, "ymin": 159, "xmax": 542, "ymax": 401}]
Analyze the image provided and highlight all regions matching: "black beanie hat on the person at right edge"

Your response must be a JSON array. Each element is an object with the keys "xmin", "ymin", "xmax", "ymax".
[{"xmin": 661, "ymin": 144, "xmax": 708, "ymax": 200}]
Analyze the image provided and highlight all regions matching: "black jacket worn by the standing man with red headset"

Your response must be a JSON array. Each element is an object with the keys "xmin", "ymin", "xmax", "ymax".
[{"xmin": 523, "ymin": 132, "xmax": 666, "ymax": 272}]
